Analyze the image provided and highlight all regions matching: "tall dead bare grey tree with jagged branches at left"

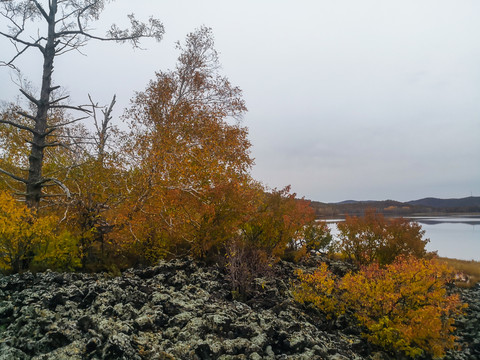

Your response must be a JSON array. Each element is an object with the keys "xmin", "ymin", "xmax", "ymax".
[{"xmin": 0, "ymin": 0, "xmax": 164, "ymax": 208}]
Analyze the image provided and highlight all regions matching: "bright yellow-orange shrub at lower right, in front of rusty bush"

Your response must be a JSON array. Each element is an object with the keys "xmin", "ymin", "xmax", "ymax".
[{"xmin": 294, "ymin": 256, "xmax": 465, "ymax": 358}]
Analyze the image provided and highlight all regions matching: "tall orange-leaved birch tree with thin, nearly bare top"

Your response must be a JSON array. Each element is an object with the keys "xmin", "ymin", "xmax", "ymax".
[{"xmin": 114, "ymin": 27, "xmax": 253, "ymax": 262}]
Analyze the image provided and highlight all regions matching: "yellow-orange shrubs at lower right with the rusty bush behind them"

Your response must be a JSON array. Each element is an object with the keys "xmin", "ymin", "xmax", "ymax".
[{"xmin": 293, "ymin": 210, "xmax": 464, "ymax": 358}]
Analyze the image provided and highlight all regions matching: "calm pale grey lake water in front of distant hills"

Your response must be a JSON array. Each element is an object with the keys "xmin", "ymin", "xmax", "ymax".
[{"xmin": 327, "ymin": 216, "xmax": 480, "ymax": 261}]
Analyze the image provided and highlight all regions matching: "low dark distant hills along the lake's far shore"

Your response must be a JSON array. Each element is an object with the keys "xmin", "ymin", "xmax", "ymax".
[{"xmin": 311, "ymin": 196, "xmax": 480, "ymax": 218}]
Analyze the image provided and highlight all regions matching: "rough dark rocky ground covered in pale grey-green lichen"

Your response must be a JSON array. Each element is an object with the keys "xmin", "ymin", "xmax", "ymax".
[{"xmin": 0, "ymin": 260, "xmax": 480, "ymax": 360}]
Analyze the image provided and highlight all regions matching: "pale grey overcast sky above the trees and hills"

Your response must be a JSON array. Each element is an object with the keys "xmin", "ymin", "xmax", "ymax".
[{"xmin": 0, "ymin": 0, "xmax": 480, "ymax": 202}]
